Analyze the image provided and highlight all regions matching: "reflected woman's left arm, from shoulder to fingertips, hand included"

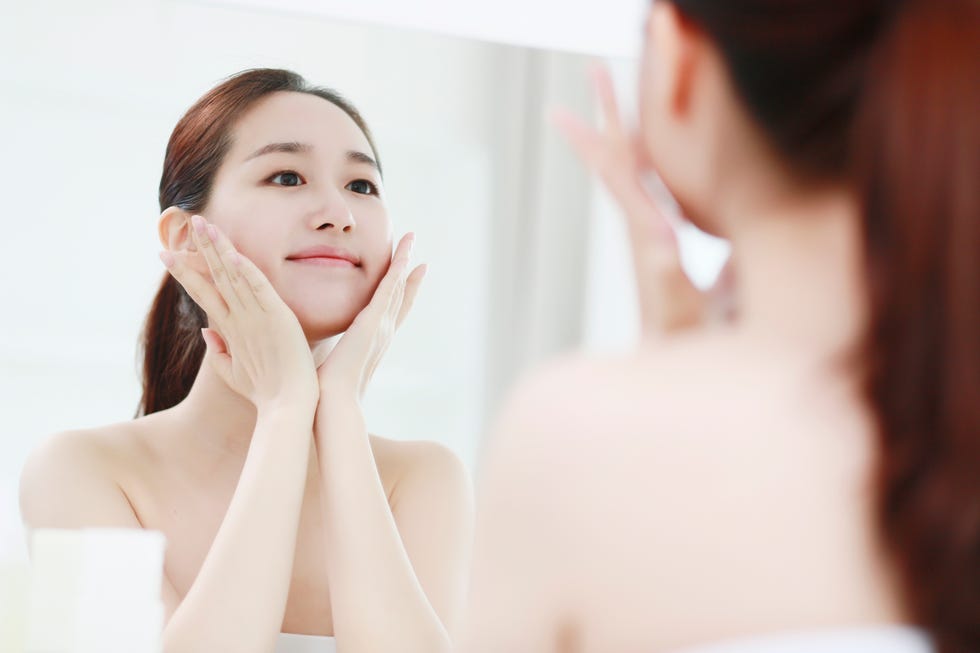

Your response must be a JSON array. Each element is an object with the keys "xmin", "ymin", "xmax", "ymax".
[{"xmin": 21, "ymin": 216, "xmax": 318, "ymax": 653}]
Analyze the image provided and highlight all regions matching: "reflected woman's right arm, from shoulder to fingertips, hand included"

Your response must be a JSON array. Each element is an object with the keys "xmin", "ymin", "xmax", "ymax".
[{"xmin": 314, "ymin": 235, "xmax": 472, "ymax": 653}]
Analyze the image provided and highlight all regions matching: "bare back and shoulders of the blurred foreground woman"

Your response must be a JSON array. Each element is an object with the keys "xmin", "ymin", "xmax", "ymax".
[{"xmin": 474, "ymin": 334, "xmax": 873, "ymax": 650}]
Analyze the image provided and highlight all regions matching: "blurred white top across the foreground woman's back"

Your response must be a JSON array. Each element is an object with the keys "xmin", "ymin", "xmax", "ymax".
[{"xmin": 674, "ymin": 626, "xmax": 935, "ymax": 653}]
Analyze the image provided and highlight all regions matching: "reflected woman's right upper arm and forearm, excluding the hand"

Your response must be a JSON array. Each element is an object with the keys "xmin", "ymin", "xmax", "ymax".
[{"xmin": 316, "ymin": 396, "xmax": 472, "ymax": 653}]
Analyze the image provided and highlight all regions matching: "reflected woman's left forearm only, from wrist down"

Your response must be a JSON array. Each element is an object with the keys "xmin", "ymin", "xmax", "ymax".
[{"xmin": 164, "ymin": 407, "xmax": 312, "ymax": 653}]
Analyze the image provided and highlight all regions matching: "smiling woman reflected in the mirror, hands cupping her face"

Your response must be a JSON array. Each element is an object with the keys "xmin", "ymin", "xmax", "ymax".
[{"xmin": 21, "ymin": 70, "xmax": 472, "ymax": 653}]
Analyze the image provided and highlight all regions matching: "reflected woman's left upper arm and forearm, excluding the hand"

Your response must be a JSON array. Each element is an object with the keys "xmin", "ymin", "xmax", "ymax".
[{"xmin": 20, "ymin": 402, "xmax": 312, "ymax": 653}]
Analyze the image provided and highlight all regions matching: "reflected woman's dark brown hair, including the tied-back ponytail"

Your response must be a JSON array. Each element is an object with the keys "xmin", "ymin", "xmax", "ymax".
[{"xmin": 136, "ymin": 68, "xmax": 381, "ymax": 416}]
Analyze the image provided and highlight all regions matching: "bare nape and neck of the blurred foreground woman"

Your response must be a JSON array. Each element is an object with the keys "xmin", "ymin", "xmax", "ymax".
[{"xmin": 725, "ymin": 177, "xmax": 866, "ymax": 356}]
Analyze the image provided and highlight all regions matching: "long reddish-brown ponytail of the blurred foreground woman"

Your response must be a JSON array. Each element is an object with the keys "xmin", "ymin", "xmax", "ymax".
[{"xmin": 852, "ymin": 0, "xmax": 980, "ymax": 653}]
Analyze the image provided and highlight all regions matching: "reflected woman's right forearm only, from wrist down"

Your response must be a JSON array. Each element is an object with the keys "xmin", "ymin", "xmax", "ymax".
[{"xmin": 315, "ymin": 394, "xmax": 450, "ymax": 653}]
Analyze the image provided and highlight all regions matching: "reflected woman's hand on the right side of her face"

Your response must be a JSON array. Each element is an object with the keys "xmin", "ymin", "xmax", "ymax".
[{"xmin": 315, "ymin": 234, "xmax": 426, "ymax": 401}]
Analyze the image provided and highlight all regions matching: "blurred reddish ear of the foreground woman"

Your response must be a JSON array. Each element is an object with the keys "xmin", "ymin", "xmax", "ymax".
[{"xmin": 646, "ymin": 2, "xmax": 707, "ymax": 118}]
